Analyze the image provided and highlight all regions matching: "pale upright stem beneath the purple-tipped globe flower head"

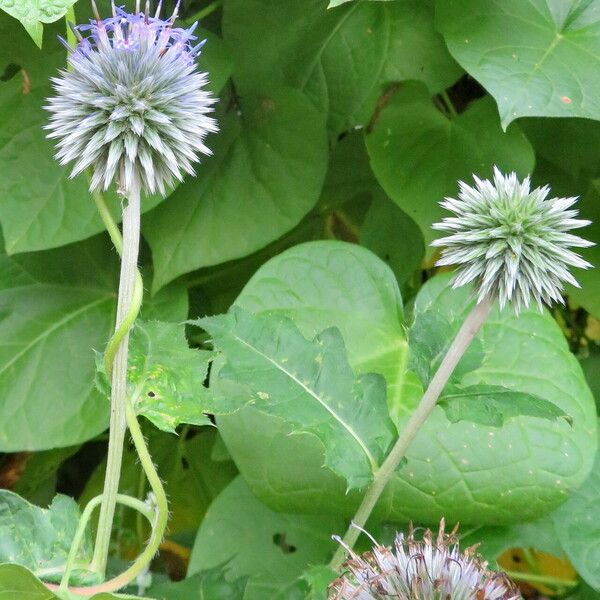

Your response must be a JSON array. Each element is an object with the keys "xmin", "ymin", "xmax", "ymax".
[{"xmin": 91, "ymin": 182, "xmax": 143, "ymax": 575}]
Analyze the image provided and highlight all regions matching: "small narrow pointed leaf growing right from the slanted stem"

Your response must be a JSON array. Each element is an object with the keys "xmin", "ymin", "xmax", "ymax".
[{"xmin": 439, "ymin": 385, "xmax": 572, "ymax": 427}]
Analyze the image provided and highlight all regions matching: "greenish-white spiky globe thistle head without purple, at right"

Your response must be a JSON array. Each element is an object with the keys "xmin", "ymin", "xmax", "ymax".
[{"xmin": 431, "ymin": 167, "xmax": 593, "ymax": 314}]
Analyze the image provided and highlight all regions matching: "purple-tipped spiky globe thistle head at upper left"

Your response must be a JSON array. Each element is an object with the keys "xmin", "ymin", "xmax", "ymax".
[{"xmin": 46, "ymin": 0, "xmax": 217, "ymax": 195}]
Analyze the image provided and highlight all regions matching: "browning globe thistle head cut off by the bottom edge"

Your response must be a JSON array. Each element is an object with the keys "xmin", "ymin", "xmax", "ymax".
[{"xmin": 328, "ymin": 520, "xmax": 521, "ymax": 600}]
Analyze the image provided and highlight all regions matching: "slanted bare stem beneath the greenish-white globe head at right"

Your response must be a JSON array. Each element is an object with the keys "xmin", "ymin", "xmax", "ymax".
[{"xmin": 329, "ymin": 297, "xmax": 493, "ymax": 571}]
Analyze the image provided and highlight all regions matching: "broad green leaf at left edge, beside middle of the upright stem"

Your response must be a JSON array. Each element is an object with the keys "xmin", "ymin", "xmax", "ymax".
[{"xmin": 0, "ymin": 236, "xmax": 117, "ymax": 452}]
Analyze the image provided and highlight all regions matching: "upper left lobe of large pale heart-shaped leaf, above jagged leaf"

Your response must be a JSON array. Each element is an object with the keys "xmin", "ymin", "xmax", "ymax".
[{"xmin": 225, "ymin": 241, "xmax": 408, "ymax": 420}]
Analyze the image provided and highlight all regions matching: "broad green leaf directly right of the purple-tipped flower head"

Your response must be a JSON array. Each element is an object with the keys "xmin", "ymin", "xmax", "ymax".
[{"xmin": 144, "ymin": 89, "xmax": 327, "ymax": 290}]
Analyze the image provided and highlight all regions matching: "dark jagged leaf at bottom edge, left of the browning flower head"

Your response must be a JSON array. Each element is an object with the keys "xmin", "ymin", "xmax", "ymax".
[{"xmin": 147, "ymin": 566, "xmax": 248, "ymax": 600}]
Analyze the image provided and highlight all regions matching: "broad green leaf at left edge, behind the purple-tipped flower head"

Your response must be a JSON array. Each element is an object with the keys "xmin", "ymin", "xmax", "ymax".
[{"xmin": 0, "ymin": 41, "xmax": 161, "ymax": 254}]
